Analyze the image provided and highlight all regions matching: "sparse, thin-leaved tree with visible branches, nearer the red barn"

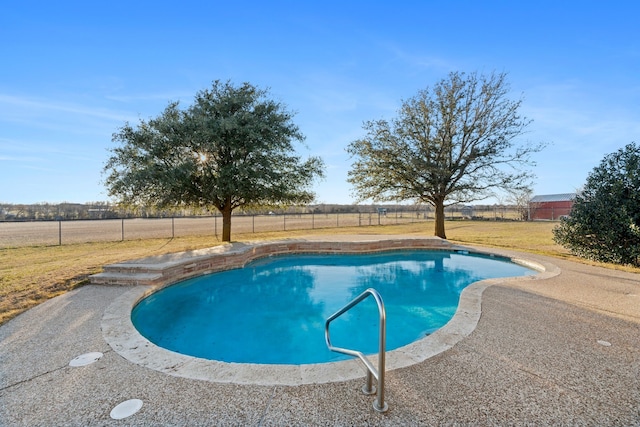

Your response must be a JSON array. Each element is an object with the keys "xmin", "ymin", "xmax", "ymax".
[{"xmin": 347, "ymin": 72, "xmax": 542, "ymax": 238}]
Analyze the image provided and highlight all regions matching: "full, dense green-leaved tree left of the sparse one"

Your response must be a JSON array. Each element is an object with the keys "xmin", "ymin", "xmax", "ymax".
[{"xmin": 104, "ymin": 81, "xmax": 324, "ymax": 241}]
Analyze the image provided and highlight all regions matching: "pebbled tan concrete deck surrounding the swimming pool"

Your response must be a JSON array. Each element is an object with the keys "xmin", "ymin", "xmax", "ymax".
[{"xmin": 0, "ymin": 235, "xmax": 640, "ymax": 426}]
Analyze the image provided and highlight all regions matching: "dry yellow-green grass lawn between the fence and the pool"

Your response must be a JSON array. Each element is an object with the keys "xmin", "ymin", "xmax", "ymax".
[{"xmin": 0, "ymin": 221, "xmax": 640, "ymax": 324}]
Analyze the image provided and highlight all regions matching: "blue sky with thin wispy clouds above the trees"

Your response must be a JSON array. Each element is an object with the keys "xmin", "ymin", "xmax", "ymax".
[{"xmin": 0, "ymin": 0, "xmax": 640, "ymax": 203}]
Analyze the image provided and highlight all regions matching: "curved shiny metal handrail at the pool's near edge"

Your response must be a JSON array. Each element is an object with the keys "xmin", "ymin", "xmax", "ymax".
[{"xmin": 324, "ymin": 288, "xmax": 389, "ymax": 412}]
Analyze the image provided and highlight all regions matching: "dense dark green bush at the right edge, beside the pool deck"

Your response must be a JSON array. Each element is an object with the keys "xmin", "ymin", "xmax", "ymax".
[{"xmin": 553, "ymin": 143, "xmax": 640, "ymax": 266}]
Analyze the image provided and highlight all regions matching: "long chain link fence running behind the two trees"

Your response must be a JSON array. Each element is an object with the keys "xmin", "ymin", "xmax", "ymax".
[{"xmin": 0, "ymin": 206, "xmax": 568, "ymax": 248}]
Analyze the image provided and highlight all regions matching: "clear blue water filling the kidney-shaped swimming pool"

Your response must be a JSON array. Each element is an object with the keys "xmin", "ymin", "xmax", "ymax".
[{"xmin": 131, "ymin": 250, "xmax": 535, "ymax": 364}]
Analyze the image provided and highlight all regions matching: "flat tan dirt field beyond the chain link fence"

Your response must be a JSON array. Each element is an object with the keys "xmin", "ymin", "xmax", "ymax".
[{"xmin": 0, "ymin": 213, "xmax": 425, "ymax": 248}]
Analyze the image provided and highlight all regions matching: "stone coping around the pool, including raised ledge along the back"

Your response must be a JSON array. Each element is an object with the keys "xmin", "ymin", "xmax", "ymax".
[{"xmin": 97, "ymin": 238, "xmax": 560, "ymax": 386}]
